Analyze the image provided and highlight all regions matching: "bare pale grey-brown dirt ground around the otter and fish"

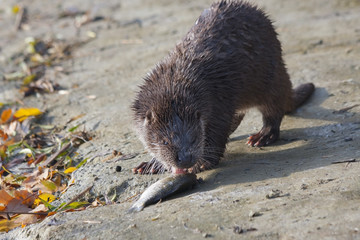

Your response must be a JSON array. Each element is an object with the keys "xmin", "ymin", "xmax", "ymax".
[{"xmin": 0, "ymin": 0, "xmax": 360, "ymax": 239}]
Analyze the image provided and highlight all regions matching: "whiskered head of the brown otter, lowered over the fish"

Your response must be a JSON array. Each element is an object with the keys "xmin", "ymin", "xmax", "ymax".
[{"xmin": 143, "ymin": 109, "xmax": 204, "ymax": 171}]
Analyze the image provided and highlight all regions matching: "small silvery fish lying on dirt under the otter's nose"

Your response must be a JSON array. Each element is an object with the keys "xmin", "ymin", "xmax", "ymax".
[{"xmin": 127, "ymin": 173, "xmax": 196, "ymax": 213}]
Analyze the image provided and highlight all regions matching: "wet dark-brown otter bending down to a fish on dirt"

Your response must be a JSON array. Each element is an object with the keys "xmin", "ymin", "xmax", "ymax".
[{"xmin": 132, "ymin": 1, "xmax": 314, "ymax": 173}]
